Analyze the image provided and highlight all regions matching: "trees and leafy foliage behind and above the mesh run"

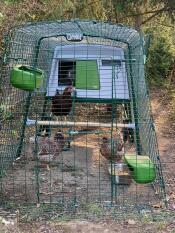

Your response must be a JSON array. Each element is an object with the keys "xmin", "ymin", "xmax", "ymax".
[{"xmin": 0, "ymin": 0, "xmax": 175, "ymax": 88}]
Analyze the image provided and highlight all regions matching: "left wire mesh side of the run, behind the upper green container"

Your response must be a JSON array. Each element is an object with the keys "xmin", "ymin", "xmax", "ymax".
[{"xmin": 0, "ymin": 30, "xmax": 39, "ymax": 173}]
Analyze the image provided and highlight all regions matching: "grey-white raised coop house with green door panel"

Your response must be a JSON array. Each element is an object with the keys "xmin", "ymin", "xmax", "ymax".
[{"xmin": 46, "ymin": 44, "xmax": 129, "ymax": 100}]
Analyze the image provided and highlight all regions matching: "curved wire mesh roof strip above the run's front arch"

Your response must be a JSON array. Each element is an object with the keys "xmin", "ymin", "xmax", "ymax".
[{"xmin": 15, "ymin": 20, "xmax": 140, "ymax": 47}]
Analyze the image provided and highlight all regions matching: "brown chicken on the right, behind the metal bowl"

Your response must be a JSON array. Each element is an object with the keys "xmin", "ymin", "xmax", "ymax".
[{"xmin": 100, "ymin": 134, "xmax": 124, "ymax": 162}]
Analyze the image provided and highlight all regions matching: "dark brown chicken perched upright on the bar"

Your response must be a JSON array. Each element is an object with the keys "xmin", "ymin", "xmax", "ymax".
[{"xmin": 52, "ymin": 86, "xmax": 74, "ymax": 116}]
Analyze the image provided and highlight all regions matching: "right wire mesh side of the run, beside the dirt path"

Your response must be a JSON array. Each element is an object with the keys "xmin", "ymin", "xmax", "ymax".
[{"xmin": 131, "ymin": 44, "xmax": 165, "ymax": 198}]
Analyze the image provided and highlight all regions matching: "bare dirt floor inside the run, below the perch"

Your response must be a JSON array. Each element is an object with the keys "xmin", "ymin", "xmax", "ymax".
[{"xmin": 1, "ymin": 129, "xmax": 159, "ymax": 212}]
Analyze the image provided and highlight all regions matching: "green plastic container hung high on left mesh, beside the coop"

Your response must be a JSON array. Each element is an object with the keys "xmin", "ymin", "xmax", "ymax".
[{"xmin": 10, "ymin": 65, "xmax": 44, "ymax": 91}]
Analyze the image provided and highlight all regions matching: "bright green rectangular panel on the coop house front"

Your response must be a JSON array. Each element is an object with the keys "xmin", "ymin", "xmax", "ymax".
[{"xmin": 75, "ymin": 60, "xmax": 100, "ymax": 90}]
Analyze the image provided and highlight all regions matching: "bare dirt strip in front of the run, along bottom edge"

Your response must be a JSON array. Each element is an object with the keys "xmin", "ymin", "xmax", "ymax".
[{"xmin": 0, "ymin": 216, "xmax": 175, "ymax": 233}]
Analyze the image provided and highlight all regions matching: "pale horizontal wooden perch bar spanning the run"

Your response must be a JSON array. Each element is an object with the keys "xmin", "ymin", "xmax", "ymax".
[{"xmin": 26, "ymin": 119, "xmax": 135, "ymax": 129}]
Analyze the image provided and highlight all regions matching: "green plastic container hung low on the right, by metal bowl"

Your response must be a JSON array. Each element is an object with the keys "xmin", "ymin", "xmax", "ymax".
[{"xmin": 125, "ymin": 155, "xmax": 156, "ymax": 184}]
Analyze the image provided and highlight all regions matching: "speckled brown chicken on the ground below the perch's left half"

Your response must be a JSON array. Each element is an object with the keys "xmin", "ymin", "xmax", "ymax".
[{"xmin": 38, "ymin": 132, "xmax": 65, "ymax": 167}]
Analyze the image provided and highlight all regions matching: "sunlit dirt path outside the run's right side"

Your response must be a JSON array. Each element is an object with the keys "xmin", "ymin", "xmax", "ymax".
[{"xmin": 151, "ymin": 90, "xmax": 175, "ymax": 209}]
